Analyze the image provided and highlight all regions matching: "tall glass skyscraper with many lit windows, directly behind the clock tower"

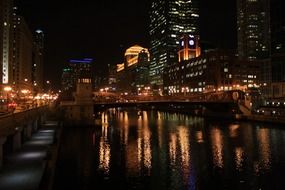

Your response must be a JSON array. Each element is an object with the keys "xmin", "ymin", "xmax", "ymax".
[{"xmin": 149, "ymin": 0, "xmax": 199, "ymax": 87}]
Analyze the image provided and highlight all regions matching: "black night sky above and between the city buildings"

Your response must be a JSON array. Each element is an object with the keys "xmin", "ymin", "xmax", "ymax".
[{"xmin": 16, "ymin": 0, "xmax": 236, "ymax": 87}]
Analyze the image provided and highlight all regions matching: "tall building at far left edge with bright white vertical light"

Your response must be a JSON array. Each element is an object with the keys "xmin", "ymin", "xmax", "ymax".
[{"xmin": 0, "ymin": 0, "xmax": 13, "ymax": 85}]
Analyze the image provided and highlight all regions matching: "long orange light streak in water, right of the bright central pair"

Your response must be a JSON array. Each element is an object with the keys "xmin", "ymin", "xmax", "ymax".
[{"xmin": 211, "ymin": 128, "xmax": 224, "ymax": 168}]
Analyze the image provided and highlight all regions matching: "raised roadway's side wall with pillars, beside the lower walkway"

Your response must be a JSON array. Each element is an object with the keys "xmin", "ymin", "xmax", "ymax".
[{"xmin": 0, "ymin": 106, "xmax": 48, "ymax": 167}]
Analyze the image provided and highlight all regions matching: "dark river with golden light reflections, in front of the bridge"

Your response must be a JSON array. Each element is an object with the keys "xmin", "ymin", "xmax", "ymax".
[{"xmin": 54, "ymin": 109, "xmax": 285, "ymax": 190}]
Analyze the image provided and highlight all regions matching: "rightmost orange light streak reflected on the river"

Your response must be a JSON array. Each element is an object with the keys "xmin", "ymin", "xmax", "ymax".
[{"xmin": 257, "ymin": 129, "xmax": 271, "ymax": 170}]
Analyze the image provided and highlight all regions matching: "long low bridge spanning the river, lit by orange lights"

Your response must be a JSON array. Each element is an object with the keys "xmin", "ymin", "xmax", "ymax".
[{"xmin": 94, "ymin": 90, "xmax": 244, "ymax": 111}]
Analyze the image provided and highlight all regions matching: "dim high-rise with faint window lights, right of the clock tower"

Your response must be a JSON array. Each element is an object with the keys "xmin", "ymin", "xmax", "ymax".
[{"xmin": 237, "ymin": 0, "xmax": 270, "ymax": 61}]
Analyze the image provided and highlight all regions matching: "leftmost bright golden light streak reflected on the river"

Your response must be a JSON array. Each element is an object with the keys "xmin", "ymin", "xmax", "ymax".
[{"xmin": 99, "ymin": 125, "xmax": 111, "ymax": 174}]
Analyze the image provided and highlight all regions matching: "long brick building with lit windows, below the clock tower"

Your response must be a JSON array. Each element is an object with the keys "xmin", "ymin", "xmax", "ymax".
[{"xmin": 164, "ymin": 50, "xmax": 260, "ymax": 95}]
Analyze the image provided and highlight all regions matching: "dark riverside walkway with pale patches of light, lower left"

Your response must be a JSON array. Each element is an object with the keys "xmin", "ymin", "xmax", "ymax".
[{"xmin": 0, "ymin": 121, "xmax": 58, "ymax": 190}]
